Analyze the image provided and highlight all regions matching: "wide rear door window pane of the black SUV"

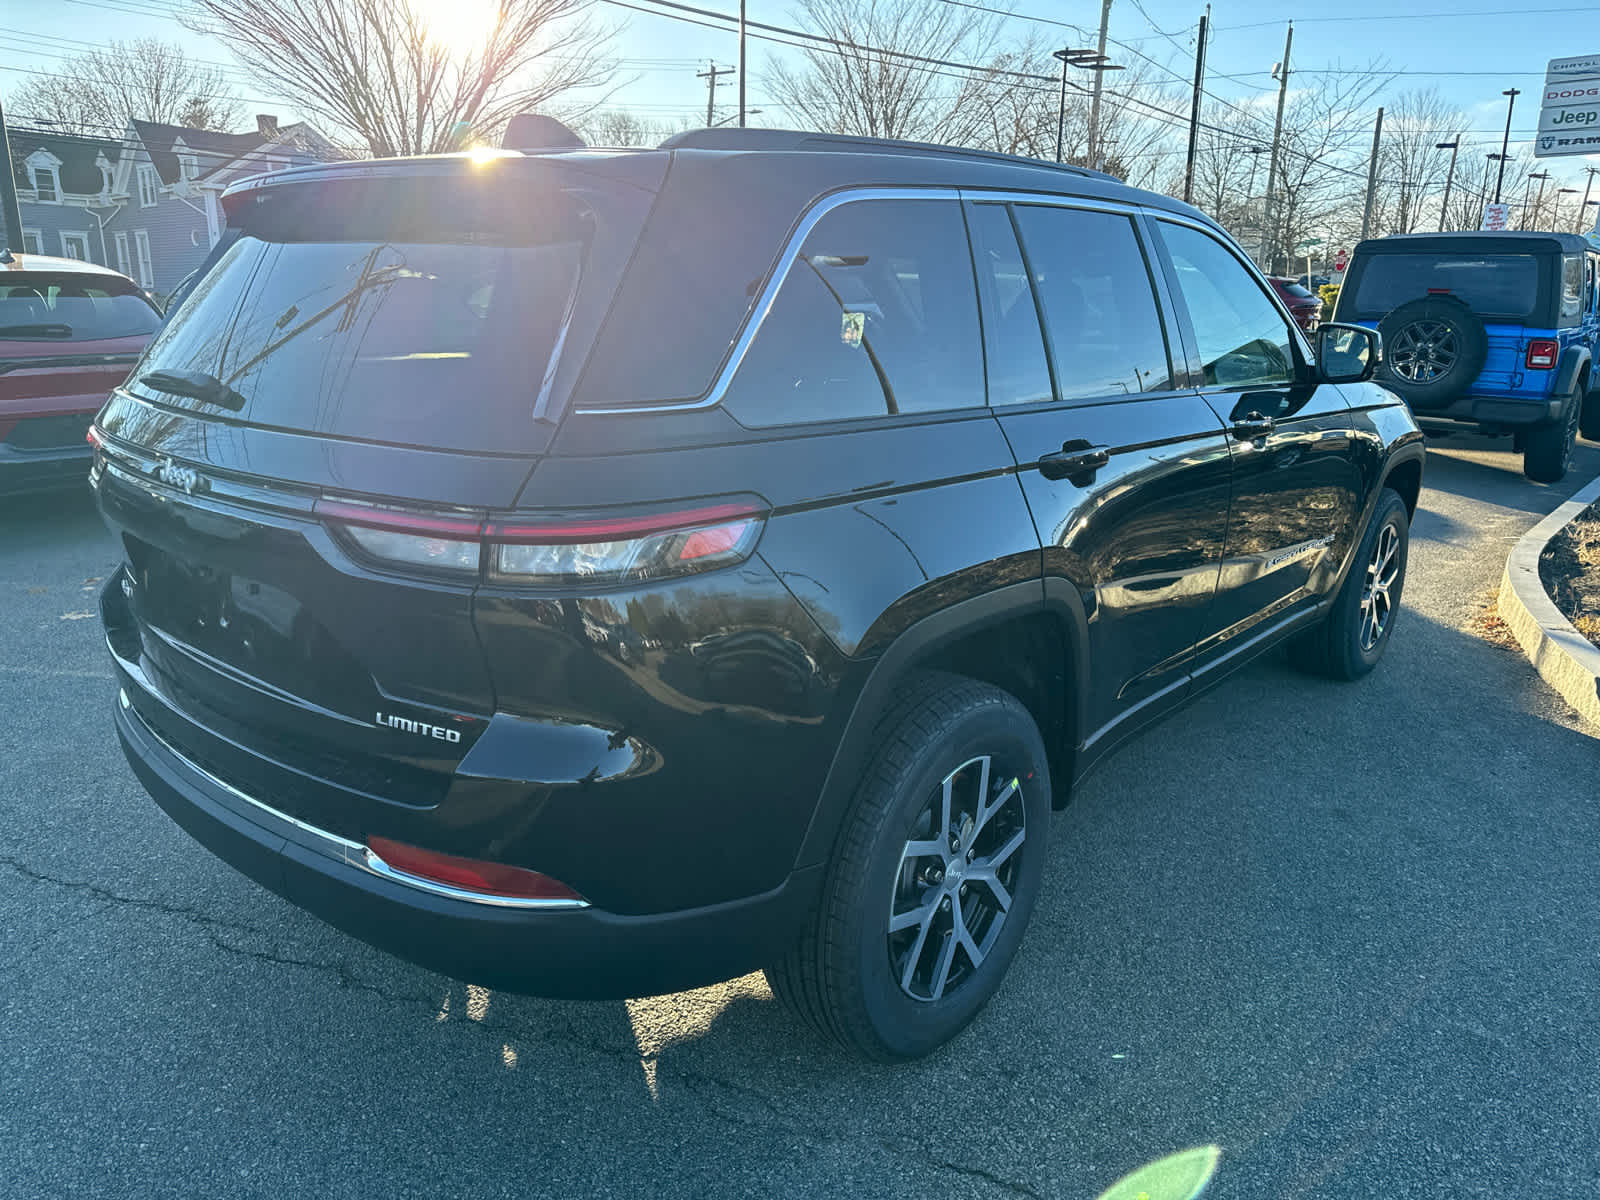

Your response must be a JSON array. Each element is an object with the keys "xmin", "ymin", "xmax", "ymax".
[{"xmin": 1014, "ymin": 205, "xmax": 1173, "ymax": 400}]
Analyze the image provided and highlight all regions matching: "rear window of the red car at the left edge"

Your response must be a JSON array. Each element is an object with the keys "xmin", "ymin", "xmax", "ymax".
[{"xmin": 0, "ymin": 270, "xmax": 162, "ymax": 342}]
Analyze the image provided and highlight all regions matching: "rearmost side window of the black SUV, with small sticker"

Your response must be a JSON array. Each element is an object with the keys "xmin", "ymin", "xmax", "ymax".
[{"xmin": 723, "ymin": 200, "xmax": 984, "ymax": 426}]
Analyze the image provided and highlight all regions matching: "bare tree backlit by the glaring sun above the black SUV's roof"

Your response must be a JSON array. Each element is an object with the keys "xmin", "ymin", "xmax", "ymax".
[{"xmin": 190, "ymin": 0, "xmax": 616, "ymax": 157}]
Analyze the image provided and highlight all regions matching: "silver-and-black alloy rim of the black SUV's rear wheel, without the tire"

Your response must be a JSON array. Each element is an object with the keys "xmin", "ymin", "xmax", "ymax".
[{"xmin": 888, "ymin": 755, "xmax": 1027, "ymax": 1003}]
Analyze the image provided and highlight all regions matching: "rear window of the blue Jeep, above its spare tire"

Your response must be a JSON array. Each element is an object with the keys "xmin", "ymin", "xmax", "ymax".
[{"xmin": 1355, "ymin": 253, "xmax": 1541, "ymax": 322}]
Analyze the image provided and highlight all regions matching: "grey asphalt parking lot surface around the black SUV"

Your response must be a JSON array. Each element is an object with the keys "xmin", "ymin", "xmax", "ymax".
[{"xmin": 0, "ymin": 440, "xmax": 1600, "ymax": 1200}]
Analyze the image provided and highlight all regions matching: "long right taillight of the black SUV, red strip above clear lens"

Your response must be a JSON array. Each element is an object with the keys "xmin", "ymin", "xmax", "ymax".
[{"xmin": 315, "ymin": 499, "xmax": 765, "ymax": 584}]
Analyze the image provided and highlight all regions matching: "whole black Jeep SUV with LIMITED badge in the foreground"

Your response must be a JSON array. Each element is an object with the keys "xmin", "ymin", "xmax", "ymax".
[{"xmin": 93, "ymin": 130, "xmax": 1422, "ymax": 1058}]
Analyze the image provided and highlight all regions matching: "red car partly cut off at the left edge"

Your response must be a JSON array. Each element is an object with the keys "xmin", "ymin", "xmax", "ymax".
[{"xmin": 0, "ymin": 251, "xmax": 162, "ymax": 494}]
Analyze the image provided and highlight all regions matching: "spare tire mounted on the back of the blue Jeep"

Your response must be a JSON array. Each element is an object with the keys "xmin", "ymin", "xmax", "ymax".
[{"xmin": 1378, "ymin": 296, "xmax": 1490, "ymax": 411}]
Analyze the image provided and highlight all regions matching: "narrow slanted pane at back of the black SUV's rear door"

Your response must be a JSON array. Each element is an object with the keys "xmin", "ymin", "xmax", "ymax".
[{"xmin": 966, "ymin": 197, "xmax": 1054, "ymax": 405}]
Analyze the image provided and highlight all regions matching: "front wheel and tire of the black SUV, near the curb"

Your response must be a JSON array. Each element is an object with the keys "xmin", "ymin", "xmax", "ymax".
[{"xmin": 1290, "ymin": 488, "xmax": 1411, "ymax": 680}]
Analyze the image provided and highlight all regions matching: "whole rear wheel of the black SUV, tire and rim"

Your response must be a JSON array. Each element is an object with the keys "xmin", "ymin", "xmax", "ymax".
[{"xmin": 766, "ymin": 672, "xmax": 1050, "ymax": 1062}]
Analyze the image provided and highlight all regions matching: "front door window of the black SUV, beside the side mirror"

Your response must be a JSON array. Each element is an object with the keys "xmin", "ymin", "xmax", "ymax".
[{"xmin": 1162, "ymin": 221, "xmax": 1294, "ymax": 387}]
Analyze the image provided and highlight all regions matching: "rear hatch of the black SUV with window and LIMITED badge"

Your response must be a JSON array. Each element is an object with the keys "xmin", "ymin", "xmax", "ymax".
[{"xmin": 96, "ymin": 155, "xmax": 664, "ymax": 832}]
